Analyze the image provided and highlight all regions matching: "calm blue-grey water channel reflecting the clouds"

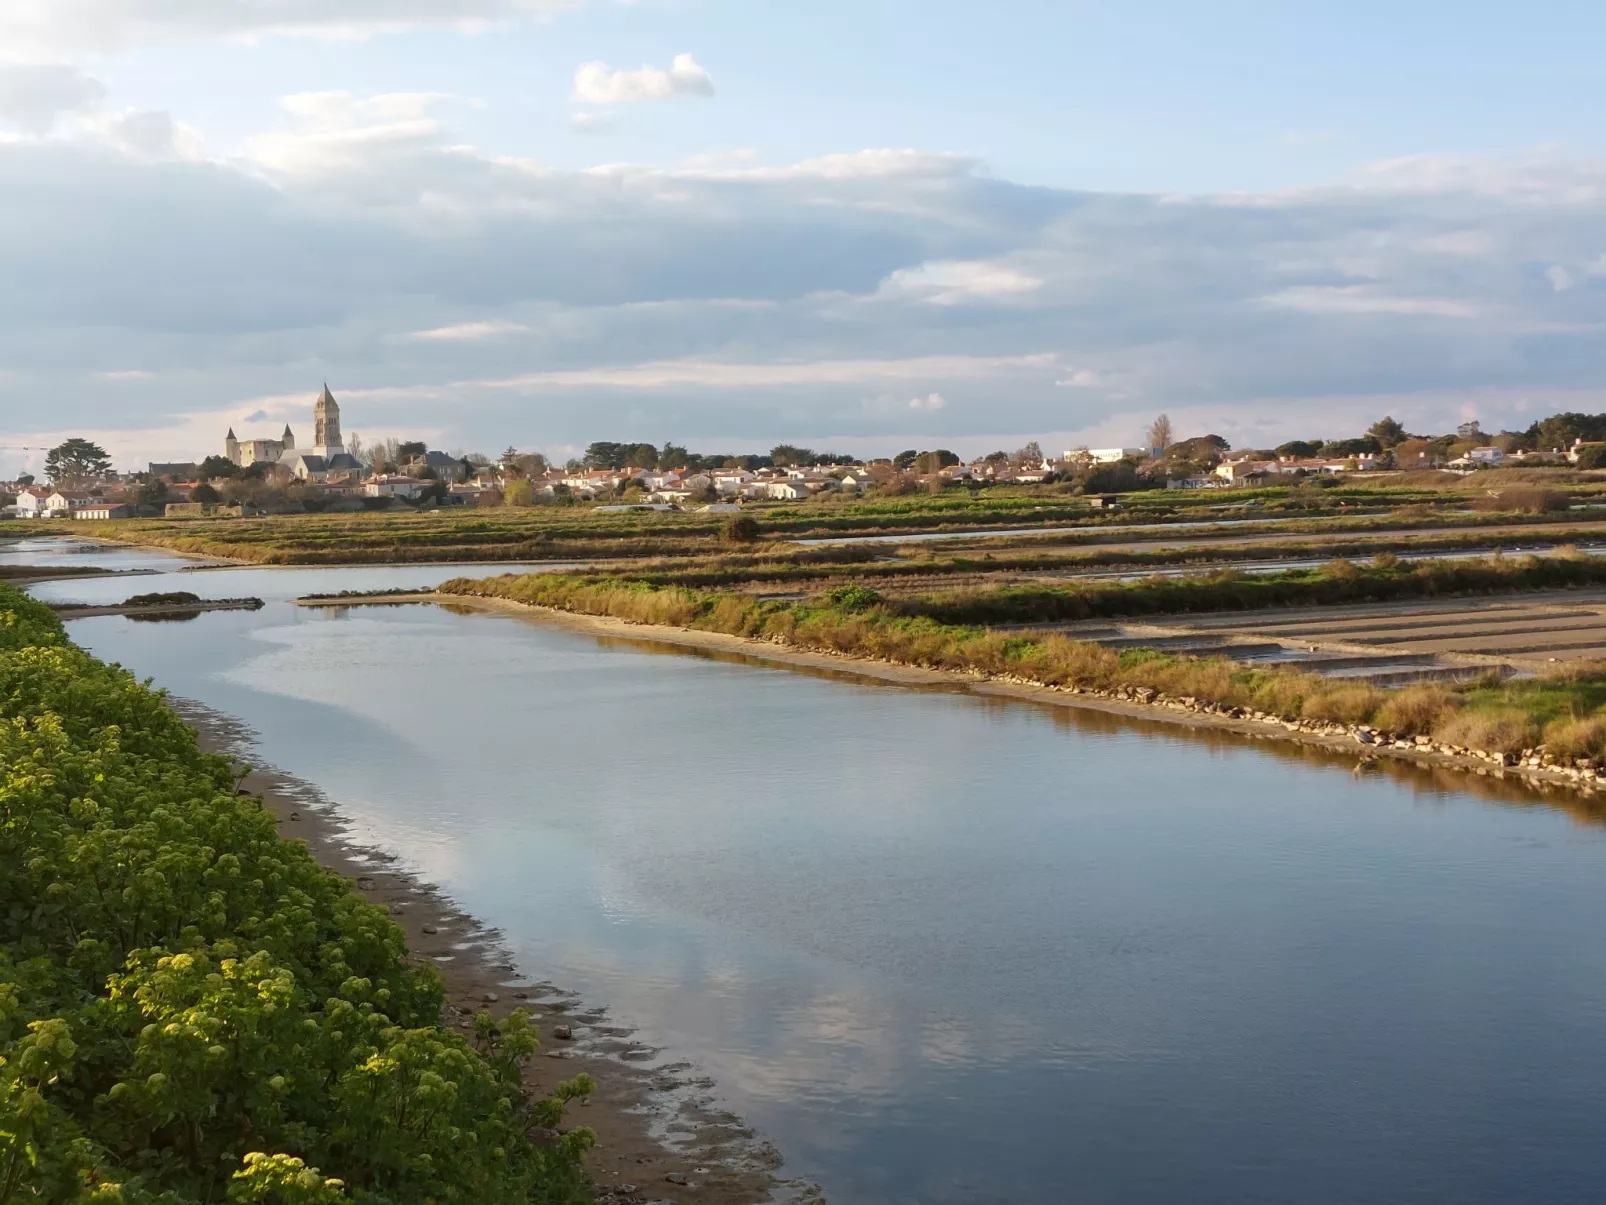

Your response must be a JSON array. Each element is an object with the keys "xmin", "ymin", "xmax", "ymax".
[{"xmin": 13, "ymin": 548, "xmax": 1606, "ymax": 1205}]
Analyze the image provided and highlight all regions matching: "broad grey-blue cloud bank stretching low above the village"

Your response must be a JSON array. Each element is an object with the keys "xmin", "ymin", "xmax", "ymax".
[{"xmin": 0, "ymin": 79, "xmax": 1606, "ymax": 456}]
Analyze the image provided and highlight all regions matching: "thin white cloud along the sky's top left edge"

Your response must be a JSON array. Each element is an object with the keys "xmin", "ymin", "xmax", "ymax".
[{"xmin": 0, "ymin": 0, "xmax": 583, "ymax": 55}]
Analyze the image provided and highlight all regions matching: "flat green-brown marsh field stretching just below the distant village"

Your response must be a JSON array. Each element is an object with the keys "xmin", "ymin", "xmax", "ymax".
[{"xmin": 28, "ymin": 474, "xmax": 1606, "ymax": 566}]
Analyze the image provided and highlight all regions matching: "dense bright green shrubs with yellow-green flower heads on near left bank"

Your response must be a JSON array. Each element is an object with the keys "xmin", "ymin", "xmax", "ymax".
[{"xmin": 0, "ymin": 586, "xmax": 589, "ymax": 1205}]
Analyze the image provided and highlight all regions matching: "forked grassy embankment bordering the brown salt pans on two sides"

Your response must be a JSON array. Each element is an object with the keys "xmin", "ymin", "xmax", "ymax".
[{"xmin": 440, "ymin": 558, "xmax": 1606, "ymax": 757}]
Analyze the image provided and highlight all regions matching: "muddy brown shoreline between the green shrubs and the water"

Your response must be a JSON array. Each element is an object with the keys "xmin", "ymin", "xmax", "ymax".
[{"xmin": 170, "ymin": 699, "xmax": 790, "ymax": 1205}]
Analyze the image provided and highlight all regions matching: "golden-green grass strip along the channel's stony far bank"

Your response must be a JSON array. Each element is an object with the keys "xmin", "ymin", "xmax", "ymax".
[{"xmin": 440, "ymin": 561, "xmax": 1606, "ymax": 774}]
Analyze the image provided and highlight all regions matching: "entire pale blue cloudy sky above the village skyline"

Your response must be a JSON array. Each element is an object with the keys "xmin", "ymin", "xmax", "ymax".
[{"xmin": 0, "ymin": 0, "xmax": 1606, "ymax": 476}]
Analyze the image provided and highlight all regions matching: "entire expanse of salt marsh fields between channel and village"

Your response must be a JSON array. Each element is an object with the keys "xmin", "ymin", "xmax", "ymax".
[{"xmin": 18, "ymin": 472, "xmax": 1606, "ymax": 755}]
